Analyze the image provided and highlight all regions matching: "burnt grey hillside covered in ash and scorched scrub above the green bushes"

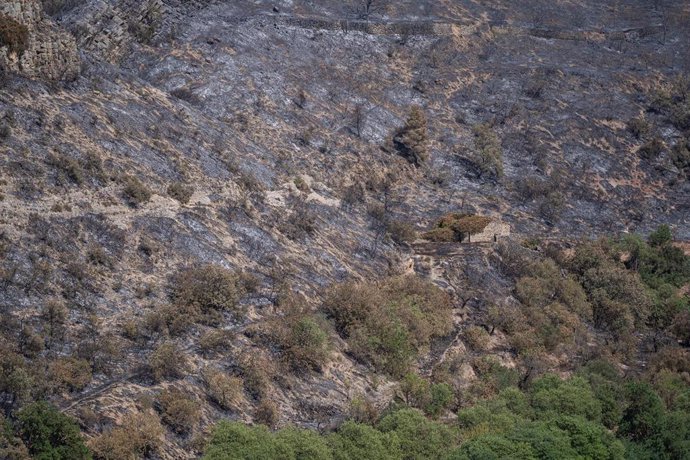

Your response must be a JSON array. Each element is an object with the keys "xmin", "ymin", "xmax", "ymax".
[{"xmin": 0, "ymin": 0, "xmax": 690, "ymax": 458}]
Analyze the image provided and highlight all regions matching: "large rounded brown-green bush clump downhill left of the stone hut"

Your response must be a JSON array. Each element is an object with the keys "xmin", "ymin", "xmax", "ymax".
[{"xmin": 324, "ymin": 276, "xmax": 453, "ymax": 377}]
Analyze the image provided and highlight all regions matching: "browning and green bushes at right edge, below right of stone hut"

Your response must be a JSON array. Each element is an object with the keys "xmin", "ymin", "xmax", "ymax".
[{"xmin": 492, "ymin": 226, "xmax": 690, "ymax": 354}]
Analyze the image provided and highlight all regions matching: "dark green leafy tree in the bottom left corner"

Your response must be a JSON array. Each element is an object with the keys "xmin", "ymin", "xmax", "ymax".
[{"xmin": 17, "ymin": 401, "xmax": 91, "ymax": 460}]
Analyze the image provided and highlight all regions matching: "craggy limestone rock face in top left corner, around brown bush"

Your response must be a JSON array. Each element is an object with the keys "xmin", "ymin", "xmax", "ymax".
[{"xmin": 0, "ymin": 0, "xmax": 80, "ymax": 81}]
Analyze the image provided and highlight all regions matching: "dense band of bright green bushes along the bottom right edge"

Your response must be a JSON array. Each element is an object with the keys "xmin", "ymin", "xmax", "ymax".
[{"xmin": 204, "ymin": 361, "xmax": 690, "ymax": 460}]
